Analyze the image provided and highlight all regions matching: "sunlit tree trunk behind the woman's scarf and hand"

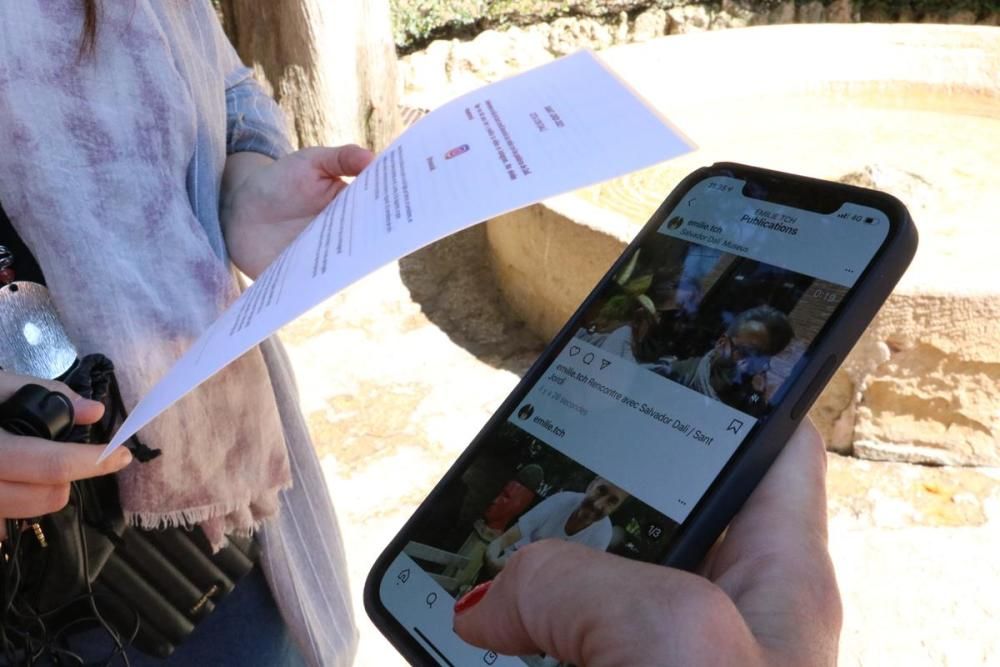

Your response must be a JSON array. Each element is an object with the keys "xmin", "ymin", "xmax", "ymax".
[{"xmin": 221, "ymin": 0, "xmax": 400, "ymax": 150}]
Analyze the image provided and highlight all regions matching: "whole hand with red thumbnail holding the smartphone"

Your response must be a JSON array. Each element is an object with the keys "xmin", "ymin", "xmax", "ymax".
[{"xmin": 455, "ymin": 424, "xmax": 841, "ymax": 667}]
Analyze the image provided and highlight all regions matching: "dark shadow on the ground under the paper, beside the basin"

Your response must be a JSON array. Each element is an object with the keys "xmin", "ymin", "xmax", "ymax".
[{"xmin": 399, "ymin": 225, "xmax": 545, "ymax": 375}]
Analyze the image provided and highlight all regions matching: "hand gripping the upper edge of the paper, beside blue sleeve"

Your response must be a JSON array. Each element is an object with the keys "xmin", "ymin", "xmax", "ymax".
[{"xmin": 220, "ymin": 145, "xmax": 374, "ymax": 278}]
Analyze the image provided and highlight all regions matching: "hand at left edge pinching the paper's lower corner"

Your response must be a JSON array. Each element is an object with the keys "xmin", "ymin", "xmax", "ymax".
[{"xmin": 0, "ymin": 371, "xmax": 132, "ymax": 540}]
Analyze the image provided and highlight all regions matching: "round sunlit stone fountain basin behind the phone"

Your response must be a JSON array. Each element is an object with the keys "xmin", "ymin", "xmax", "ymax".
[{"xmin": 487, "ymin": 24, "xmax": 1000, "ymax": 466}]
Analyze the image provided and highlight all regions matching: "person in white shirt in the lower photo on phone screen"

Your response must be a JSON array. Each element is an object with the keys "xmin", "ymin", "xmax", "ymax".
[{"xmin": 486, "ymin": 477, "xmax": 629, "ymax": 572}]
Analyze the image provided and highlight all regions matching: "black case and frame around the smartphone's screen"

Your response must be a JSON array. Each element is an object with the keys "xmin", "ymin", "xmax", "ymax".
[{"xmin": 364, "ymin": 162, "xmax": 917, "ymax": 665}]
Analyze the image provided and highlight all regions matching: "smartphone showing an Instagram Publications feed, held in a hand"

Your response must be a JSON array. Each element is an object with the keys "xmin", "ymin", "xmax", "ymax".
[{"xmin": 365, "ymin": 163, "xmax": 917, "ymax": 666}]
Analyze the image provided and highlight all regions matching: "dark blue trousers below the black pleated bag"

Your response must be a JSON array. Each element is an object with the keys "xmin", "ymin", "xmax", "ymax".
[{"xmin": 69, "ymin": 567, "xmax": 305, "ymax": 667}]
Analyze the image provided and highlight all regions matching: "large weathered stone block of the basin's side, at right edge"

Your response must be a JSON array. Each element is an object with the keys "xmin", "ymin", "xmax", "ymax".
[{"xmin": 849, "ymin": 294, "xmax": 1000, "ymax": 466}]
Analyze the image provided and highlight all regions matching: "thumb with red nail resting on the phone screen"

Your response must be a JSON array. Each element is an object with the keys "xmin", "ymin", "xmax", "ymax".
[{"xmin": 455, "ymin": 540, "xmax": 718, "ymax": 665}]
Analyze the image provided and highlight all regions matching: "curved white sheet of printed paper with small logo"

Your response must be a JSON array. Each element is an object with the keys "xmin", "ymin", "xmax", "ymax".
[{"xmin": 101, "ymin": 52, "xmax": 693, "ymax": 458}]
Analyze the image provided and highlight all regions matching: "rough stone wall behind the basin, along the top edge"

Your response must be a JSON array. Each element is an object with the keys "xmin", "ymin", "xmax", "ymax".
[{"xmin": 394, "ymin": 0, "xmax": 1000, "ymax": 108}]
